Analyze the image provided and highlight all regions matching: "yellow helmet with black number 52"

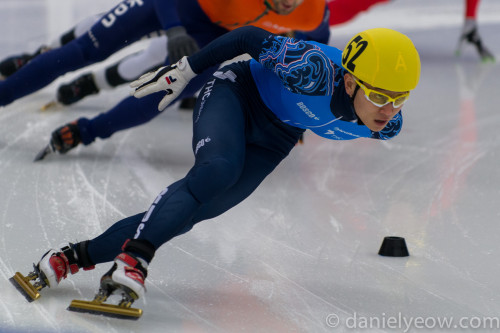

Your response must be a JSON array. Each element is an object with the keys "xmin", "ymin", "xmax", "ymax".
[{"xmin": 342, "ymin": 28, "xmax": 420, "ymax": 92}]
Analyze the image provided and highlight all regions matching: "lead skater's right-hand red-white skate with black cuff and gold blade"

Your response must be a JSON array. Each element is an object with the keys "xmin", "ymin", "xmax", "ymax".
[{"xmin": 68, "ymin": 240, "xmax": 155, "ymax": 319}]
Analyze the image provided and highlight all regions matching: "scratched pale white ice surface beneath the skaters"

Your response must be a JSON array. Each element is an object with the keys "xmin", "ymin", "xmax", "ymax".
[{"xmin": 0, "ymin": 0, "xmax": 500, "ymax": 333}]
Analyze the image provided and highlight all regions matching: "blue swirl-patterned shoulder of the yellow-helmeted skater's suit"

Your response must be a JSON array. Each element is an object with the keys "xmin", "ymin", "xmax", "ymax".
[{"xmin": 259, "ymin": 36, "xmax": 335, "ymax": 96}]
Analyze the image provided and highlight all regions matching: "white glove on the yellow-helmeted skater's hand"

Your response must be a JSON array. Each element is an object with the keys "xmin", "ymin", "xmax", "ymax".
[{"xmin": 130, "ymin": 57, "xmax": 196, "ymax": 111}]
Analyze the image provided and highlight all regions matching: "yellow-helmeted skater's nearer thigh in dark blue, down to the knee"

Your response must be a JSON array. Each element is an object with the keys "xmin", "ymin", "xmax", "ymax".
[{"xmin": 186, "ymin": 78, "xmax": 246, "ymax": 203}]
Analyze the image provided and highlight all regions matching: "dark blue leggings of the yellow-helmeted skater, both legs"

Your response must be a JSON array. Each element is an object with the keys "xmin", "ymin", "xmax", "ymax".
[{"xmin": 88, "ymin": 62, "xmax": 303, "ymax": 264}]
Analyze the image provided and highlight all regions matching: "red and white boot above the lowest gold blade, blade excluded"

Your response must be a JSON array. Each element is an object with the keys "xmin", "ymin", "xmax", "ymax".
[{"xmin": 101, "ymin": 252, "xmax": 148, "ymax": 300}]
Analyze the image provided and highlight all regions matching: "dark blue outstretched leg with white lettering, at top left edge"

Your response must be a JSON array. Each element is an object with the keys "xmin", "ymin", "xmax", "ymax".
[{"xmin": 0, "ymin": 0, "xmax": 162, "ymax": 106}]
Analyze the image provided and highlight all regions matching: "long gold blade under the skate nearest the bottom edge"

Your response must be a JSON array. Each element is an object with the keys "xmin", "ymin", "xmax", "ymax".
[{"xmin": 68, "ymin": 300, "xmax": 142, "ymax": 320}]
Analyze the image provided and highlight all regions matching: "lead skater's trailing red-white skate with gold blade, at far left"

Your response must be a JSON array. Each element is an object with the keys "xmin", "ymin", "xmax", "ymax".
[{"xmin": 11, "ymin": 242, "xmax": 94, "ymax": 302}]
